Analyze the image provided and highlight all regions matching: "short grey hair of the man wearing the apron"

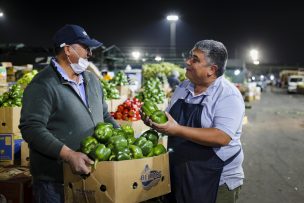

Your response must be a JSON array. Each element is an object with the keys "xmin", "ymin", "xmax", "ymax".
[{"xmin": 193, "ymin": 40, "xmax": 228, "ymax": 77}]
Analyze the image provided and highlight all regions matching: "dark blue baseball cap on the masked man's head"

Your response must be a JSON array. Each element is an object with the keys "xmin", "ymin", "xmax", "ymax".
[{"xmin": 53, "ymin": 24, "xmax": 102, "ymax": 48}]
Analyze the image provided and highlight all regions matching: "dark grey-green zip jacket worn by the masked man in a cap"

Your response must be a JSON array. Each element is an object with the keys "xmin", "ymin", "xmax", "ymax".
[{"xmin": 19, "ymin": 64, "xmax": 119, "ymax": 183}]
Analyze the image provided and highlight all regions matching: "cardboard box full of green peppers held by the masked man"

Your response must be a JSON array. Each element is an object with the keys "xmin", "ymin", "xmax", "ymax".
[{"xmin": 64, "ymin": 123, "xmax": 170, "ymax": 203}]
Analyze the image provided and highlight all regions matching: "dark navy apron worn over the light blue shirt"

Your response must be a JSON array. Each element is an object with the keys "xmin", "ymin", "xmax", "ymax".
[{"xmin": 166, "ymin": 92, "xmax": 241, "ymax": 203}]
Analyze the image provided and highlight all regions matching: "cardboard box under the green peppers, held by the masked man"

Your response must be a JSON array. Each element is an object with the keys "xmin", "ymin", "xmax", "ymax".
[{"xmin": 64, "ymin": 153, "xmax": 171, "ymax": 203}]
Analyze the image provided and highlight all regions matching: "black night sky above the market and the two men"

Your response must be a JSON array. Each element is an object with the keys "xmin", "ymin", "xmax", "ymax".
[{"xmin": 0, "ymin": 0, "xmax": 304, "ymax": 66}]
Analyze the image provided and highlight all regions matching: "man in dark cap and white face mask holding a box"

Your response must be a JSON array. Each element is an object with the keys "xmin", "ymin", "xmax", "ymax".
[{"xmin": 19, "ymin": 25, "xmax": 119, "ymax": 202}]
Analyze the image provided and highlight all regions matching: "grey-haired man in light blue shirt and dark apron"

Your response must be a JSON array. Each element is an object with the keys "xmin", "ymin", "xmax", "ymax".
[{"xmin": 142, "ymin": 40, "xmax": 245, "ymax": 203}]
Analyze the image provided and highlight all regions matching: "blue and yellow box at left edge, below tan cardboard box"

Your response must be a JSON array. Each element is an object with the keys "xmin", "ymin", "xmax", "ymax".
[{"xmin": 0, "ymin": 134, "xmax": 24, "ymax": 166}]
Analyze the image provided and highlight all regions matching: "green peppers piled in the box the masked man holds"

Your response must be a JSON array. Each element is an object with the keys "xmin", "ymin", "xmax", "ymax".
[{"xmin": 80, "ymin": 123, "xmax": 166, "ymax": 168}]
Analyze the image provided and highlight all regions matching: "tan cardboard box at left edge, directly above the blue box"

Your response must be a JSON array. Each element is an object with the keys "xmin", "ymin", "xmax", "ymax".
[{"xmin": 0, "ymin": 107, "xmax": 21, "ymax": 133}]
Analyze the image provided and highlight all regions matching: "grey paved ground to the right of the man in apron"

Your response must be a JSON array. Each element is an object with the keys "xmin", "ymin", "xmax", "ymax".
[{"xmin": 238, "ymin": 86, "xmax": 304, "ymax": 203}]
